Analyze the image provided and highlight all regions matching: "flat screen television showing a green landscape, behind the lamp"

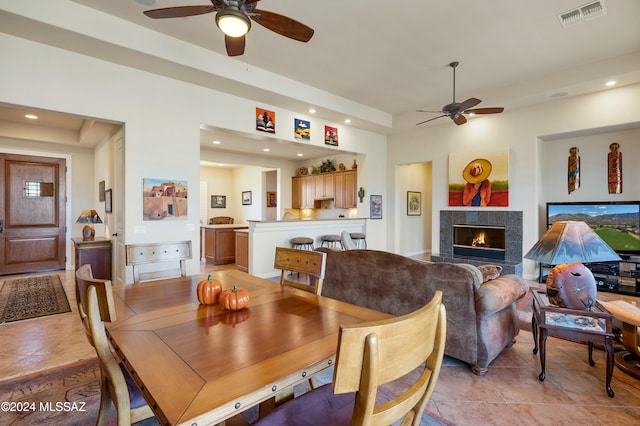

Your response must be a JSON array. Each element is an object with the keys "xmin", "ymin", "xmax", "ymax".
[{"xmin": 547, "ymin": 201, "xmax": 640, "ymax": 255}]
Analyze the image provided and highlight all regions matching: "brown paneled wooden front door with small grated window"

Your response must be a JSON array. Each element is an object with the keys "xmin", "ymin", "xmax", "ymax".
[{"xmin": 0, "ymin": 153, "xmax": 66, "ymax": 275}]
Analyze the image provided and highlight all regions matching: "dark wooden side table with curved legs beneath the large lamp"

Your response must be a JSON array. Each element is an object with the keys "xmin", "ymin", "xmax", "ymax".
[{"xmin": 530, "ymin": 289, "xmax": 615, "ymax": 398}]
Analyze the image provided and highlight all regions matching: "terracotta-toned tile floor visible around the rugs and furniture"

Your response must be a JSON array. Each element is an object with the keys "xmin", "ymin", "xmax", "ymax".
[{"xmin": 0, "ymin": 266, "xmax": 640, "ymax": 425}]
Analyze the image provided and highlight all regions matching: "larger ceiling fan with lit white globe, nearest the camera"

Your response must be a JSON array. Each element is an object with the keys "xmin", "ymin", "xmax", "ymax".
[{"xmin": 144, "ymin": 0, "xmax": 314, "ymax": 56}]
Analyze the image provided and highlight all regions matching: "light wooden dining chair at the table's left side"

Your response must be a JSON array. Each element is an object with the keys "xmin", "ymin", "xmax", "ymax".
[{"xmin": 76, "ymin": 264, "xmax": 153, "ymax": 426}]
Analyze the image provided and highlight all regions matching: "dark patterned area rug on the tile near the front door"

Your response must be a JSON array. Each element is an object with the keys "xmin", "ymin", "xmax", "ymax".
[{"xmin": 0, "ymin": 275, "xmax": 71, "ymax": 323}]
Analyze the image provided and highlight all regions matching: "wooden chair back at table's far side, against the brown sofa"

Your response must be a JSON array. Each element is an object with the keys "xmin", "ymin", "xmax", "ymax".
[{"xmin": 273, "ymin": 247, "xmax": 327, "ymax": 294}]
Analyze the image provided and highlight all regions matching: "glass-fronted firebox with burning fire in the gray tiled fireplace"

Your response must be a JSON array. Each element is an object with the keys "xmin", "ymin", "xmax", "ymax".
[{"xmin": 453, "ymin": 225, "xmax": 505, "ymax": 260}]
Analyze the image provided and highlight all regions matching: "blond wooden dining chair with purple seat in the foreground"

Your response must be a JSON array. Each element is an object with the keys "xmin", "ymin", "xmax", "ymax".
[{"xmin": 254, "ymin": 291, "xmax": 447, "ymax": 426}]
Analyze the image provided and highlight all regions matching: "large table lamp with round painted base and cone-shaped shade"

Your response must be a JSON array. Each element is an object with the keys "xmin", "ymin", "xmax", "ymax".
[{"xmin": 524, "ymin": 221, "xmax": 622, "ymax": 310}]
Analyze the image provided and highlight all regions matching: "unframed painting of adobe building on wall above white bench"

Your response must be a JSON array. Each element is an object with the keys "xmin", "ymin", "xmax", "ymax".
[{"xmin": 142, "ymin": 178, "xmax": 189, "ymax": 220}]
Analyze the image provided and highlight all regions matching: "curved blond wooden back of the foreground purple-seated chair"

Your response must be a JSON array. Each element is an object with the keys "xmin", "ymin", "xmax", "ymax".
[{"xmin": 333, "ymin": 291, "xmax": 447, "ymax": 425}]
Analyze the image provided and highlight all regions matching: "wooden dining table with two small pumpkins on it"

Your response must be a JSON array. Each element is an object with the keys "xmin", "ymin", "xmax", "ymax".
[{"xmin": 107, "ymin": 270, "xmax": 390, "ymax": 425}]
